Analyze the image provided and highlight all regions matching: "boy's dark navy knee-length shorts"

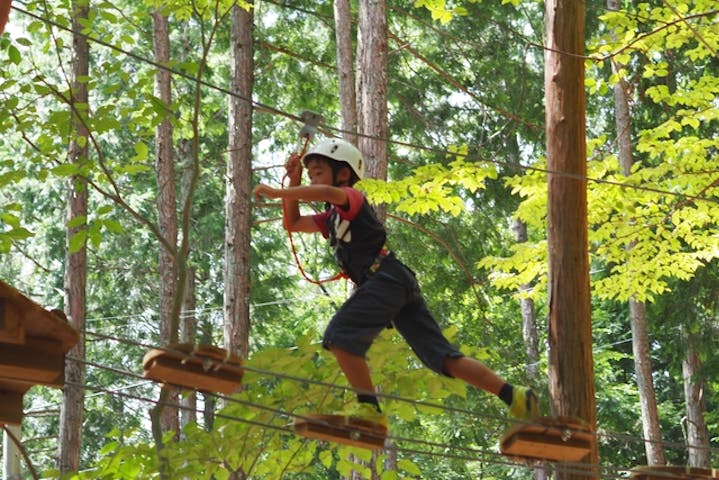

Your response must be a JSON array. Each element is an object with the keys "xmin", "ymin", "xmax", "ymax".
[{"xmin": 322, "ymin": 255, "xmax": 463, "ymax": 375}]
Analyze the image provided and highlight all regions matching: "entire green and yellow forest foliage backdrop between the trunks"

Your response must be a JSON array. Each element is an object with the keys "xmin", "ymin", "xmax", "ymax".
[{"xmin": 0, "ymin": 0, "xmax": 719, "ymax": 480}]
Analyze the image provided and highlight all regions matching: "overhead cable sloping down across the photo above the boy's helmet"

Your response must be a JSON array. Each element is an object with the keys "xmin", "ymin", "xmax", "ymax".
[{"xmin": 12, "ymin": 5, "xmax": 719, "ymax": 208}]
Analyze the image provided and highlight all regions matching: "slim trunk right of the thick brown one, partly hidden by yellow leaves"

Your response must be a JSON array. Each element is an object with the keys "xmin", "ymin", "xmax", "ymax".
[{"xmin": 607, "ymin": 0, "xmax": 666, "ymax": 465}]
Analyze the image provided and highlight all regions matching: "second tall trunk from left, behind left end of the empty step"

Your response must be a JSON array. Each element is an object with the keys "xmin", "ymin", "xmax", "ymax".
[{"xmin": 152, "ymin": 10, "xmax": 179, "ymax": 458}]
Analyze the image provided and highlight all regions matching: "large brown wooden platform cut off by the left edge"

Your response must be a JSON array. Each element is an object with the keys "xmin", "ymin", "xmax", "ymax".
[{"xmin": 0, "ymin": 280, "xmax": 80, "ymax": 425}]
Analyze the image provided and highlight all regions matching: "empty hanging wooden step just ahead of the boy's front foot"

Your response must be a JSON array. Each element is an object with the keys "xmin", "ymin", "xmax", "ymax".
[{"xmin": 142, "ymin": 343, "xmax": 244, "ymax": 395}]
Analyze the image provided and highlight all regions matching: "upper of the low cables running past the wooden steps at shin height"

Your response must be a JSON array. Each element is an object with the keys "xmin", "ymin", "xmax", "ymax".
[{"xmin": 71, "ymin": 332, "xmax": 719, "ymax": 460}]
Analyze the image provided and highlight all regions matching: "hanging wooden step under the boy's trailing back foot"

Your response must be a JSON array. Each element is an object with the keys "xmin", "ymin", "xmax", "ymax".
[{"xmin": 499, "ymin": 417, "xmax": 595, "ymax": 462}]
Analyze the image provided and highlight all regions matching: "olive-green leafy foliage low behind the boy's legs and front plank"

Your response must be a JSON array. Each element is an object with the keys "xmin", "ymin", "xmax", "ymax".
[{"xmin": 40, "ymin": 332, "xmax": 484, "ymax": 480}]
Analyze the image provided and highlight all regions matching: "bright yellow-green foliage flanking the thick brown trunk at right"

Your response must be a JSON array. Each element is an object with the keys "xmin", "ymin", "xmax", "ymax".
[{"xmin": 481, "ymin": 2, "xmax": 719, "ymax": 301}]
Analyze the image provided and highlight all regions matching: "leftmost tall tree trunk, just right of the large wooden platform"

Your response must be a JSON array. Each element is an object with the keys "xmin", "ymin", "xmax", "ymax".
[{"xmin": 58, "ymin": 2, "xmax": 90, "ymax": 473}]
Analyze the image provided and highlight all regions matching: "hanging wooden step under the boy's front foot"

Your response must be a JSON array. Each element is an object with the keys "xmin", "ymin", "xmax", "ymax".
[{"xmin": 294, "ymin": 414, "xmax": 387, "ymax": 450}]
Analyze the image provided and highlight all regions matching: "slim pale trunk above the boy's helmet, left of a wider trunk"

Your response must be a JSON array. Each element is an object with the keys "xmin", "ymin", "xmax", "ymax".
[{"xmin": 334, "ymin": 0, "xmax": 357, "ymax": 145}]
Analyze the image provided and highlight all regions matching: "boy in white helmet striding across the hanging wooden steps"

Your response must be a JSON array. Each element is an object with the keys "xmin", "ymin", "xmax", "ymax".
[{"xmin": 253, "ymin": 139, "xmax": 539, "ymax": 426}]
